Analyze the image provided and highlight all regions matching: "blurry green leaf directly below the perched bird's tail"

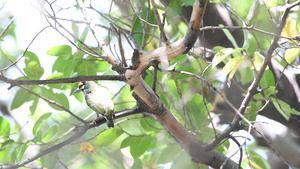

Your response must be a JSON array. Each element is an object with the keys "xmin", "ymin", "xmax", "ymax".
[{"xmin": 96, "ymin": 128, "xmax": 123, "ymax": 146}]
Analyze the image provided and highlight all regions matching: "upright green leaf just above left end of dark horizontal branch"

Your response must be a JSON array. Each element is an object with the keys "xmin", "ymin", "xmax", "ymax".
[{"xmin": 23, "ymin": 52, "xmax": 44, "ymax": 79}]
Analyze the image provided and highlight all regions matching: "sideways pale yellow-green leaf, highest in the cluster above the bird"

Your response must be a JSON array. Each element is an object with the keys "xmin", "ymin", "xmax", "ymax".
[{"xmin": 47, "ymin": 45, "xmax": 72, "ymax": 59}]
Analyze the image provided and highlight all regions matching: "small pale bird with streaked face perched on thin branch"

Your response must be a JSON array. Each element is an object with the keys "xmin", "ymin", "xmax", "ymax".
[{"xmin": 74, "ymin": 81, "xmax": 114, "ymax": 127}]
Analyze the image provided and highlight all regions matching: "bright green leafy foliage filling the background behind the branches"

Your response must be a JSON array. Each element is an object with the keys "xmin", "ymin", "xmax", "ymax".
[{"xmin": 0, "ymin": 0, "xmax": 300, "ymax": 168}]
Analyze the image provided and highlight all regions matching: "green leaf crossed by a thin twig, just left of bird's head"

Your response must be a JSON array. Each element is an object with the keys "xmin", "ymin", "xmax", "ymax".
[{"xmin": 42, "ymin": 88, "xmax": 69, "ymax": 110}]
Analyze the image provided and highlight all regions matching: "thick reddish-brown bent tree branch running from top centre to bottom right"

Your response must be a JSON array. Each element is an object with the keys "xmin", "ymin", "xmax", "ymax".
[{"xmin": 125, "ymin": 0, "xmax": 239, "ymax": 168}]
